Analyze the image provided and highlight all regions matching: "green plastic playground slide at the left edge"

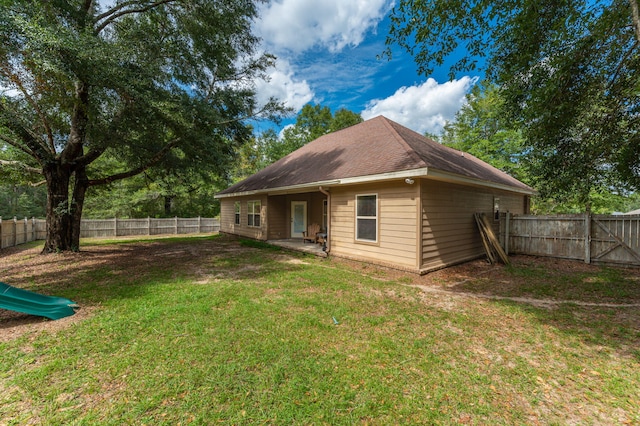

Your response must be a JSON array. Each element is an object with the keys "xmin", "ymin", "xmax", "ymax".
[{"xmin": 0, "ymin": 282, "xmax": 78, "ymax": 320}]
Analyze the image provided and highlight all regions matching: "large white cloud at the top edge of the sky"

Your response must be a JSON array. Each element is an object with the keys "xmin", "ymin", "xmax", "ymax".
[{"xmin": 257, "ymin": 0, "xmax": 392, "ymax": 52}]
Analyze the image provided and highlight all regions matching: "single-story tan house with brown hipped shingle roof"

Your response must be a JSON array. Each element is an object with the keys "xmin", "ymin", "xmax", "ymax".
[{"xmin": 216, "ymin": 116, "xmax": 534, "ymax": 273}]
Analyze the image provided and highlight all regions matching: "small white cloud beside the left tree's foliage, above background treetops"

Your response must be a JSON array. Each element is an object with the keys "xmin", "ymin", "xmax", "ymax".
[{"xmin": 256, "ymin": 60, "xmax": 314, "ymax": 112}]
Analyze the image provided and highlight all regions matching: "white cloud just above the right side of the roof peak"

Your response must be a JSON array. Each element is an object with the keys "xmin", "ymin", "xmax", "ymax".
[{"xmin": 362, "ymin": 76, "xmax": 478, "ymax": 134}]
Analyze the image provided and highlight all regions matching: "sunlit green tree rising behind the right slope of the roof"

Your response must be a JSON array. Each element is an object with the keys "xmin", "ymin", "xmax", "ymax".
[{"xmin": 441, "ymin": 83, "xmax": 530, "ymax": 183}]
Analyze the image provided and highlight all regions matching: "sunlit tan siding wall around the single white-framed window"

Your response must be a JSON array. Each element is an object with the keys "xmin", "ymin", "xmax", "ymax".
[{"xmin": 330, "ymin": 182, "xmax": 418, "ymax": 269}]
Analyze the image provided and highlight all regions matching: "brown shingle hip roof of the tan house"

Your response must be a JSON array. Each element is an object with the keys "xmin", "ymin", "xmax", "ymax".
[{"xmin": 220, "ymin": 116, "xmax": 532, "ymax": 195}]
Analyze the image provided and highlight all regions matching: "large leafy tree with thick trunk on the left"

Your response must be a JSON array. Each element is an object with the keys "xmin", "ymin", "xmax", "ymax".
[{"xmin": 0, "ymin": 0, "xmax": 279, "ymax": 252}]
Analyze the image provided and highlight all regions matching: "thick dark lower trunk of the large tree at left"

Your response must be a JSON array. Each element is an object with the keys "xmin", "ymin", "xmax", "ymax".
[{"xmin": 42, "ymin": 162, "xmax": 71, "ymax": 253}]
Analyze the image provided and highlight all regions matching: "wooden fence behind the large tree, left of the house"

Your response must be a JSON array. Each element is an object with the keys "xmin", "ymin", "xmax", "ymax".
[{"xmin": 0, "ymin": 217, "xmax": 220, "ymax": 248}]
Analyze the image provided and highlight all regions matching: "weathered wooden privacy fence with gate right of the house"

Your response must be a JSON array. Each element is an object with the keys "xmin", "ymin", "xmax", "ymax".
[{"xmin": 500, "ymin": 213, "xmax": 640, "ymax": 266}]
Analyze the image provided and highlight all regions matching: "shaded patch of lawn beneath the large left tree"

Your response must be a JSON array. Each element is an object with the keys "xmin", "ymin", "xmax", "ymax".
[{"xmin": 0, "ymin": 235, "xmax": 308, "ymax": 306}]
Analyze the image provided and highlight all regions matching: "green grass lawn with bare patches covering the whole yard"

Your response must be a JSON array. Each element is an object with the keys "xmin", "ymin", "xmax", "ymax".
[{"xmin": 0, "ymin": 236, "xmax": 640, "ymax": 425}]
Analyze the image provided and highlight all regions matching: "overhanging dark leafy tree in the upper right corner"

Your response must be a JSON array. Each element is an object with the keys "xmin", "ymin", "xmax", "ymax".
[{"xmin": 387, "ymin": 0, "xmax": 640, "ymax": 209}]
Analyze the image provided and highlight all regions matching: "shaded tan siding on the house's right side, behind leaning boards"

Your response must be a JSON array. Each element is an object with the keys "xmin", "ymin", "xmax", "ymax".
[{"xmin": 421, "ymin": 180, "xmax": 524, "ymax": 270}]
